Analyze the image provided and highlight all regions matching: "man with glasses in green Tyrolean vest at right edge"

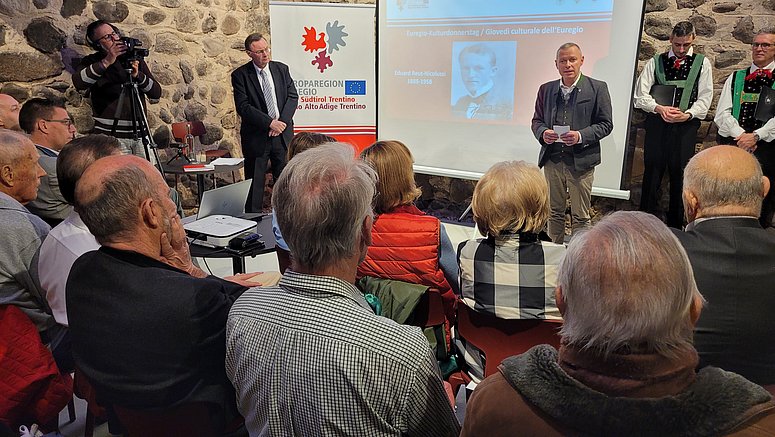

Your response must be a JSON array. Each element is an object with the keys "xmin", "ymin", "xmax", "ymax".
[{"xmin": 713, "ymin": 29, "xmax": 775, "ymax": 228}]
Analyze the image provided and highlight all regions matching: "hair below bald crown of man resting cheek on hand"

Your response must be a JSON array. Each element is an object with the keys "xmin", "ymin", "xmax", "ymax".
[{"xmin": 75, "ymin": 164, "xmax": 160, "ymax": 245}]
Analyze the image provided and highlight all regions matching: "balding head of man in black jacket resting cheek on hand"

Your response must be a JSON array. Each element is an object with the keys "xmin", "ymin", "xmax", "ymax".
[{"xmin": 75, "ymin": 155, "xmax": 166, "ymax": 245}]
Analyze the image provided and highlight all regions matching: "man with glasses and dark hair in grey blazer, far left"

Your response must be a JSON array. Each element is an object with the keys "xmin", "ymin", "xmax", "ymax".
[{"xmin": 19, "ymin": 98, "xmax": 75, "ymax": 226}]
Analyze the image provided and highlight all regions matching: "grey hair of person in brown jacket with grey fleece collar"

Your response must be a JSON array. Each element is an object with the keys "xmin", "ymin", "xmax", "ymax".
[{"xmin": 558, "ymin": 211, "xmax": 702, "ymax": 356}]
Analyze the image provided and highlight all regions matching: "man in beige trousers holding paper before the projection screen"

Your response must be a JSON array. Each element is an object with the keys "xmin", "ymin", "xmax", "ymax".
[{"xmin": 532, "ymin": 42, "xmax": 614, "ymax": 243}]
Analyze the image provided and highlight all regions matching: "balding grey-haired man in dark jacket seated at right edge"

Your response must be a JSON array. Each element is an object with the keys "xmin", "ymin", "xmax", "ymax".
[{"xmin": 674, "ymin": 146, "xmax": 775, "ymax": 384}]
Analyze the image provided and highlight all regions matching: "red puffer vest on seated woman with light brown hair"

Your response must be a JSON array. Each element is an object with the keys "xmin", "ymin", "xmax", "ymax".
[{"xmin": 358, "ymin": 205, "xmax": 455, "ymax": 320}]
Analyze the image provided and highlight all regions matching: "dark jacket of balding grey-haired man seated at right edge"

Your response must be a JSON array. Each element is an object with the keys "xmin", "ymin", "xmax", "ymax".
[{"xmin": 673, "ymin": 217, "xmax": 775, "ymax": 384}]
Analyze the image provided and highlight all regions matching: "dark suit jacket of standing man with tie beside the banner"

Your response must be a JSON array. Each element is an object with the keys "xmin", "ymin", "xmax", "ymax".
[{"xmin": 231, "ymin": 61, "xmax": 299, "ymax": 158}]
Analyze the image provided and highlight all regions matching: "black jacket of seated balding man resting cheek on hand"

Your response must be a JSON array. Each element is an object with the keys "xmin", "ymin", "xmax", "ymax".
[{"xmin": 67, "ymin": 246, "xmax": 245, "ymax": 421}]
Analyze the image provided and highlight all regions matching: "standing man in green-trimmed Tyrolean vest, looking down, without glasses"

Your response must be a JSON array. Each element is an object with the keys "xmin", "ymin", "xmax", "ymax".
[{"xmin": 635, "ymin": 21, "xmax": 713, "ymax": 228}]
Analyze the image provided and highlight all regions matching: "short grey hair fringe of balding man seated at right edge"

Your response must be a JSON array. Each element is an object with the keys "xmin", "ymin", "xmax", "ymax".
[{"xmin": 683, "ymin": 146, "xmax": 764, "ymax": 217}]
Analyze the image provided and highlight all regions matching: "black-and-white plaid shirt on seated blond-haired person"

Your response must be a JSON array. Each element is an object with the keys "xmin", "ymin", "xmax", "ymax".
[{"xmin": 458, "ymin": 233, "xmax": 565, "ymax": 319}]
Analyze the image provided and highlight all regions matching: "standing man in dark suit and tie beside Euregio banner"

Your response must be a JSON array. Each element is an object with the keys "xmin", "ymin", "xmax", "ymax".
[{"xmin": 231, "ymin": 33, "xmax": 299, "ymax": 212}]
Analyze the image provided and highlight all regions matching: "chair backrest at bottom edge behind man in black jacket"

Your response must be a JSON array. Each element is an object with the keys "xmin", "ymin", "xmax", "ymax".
[{"xmin": 113, "ymin": 402, "xmax": 218, "ymax": 437}]
